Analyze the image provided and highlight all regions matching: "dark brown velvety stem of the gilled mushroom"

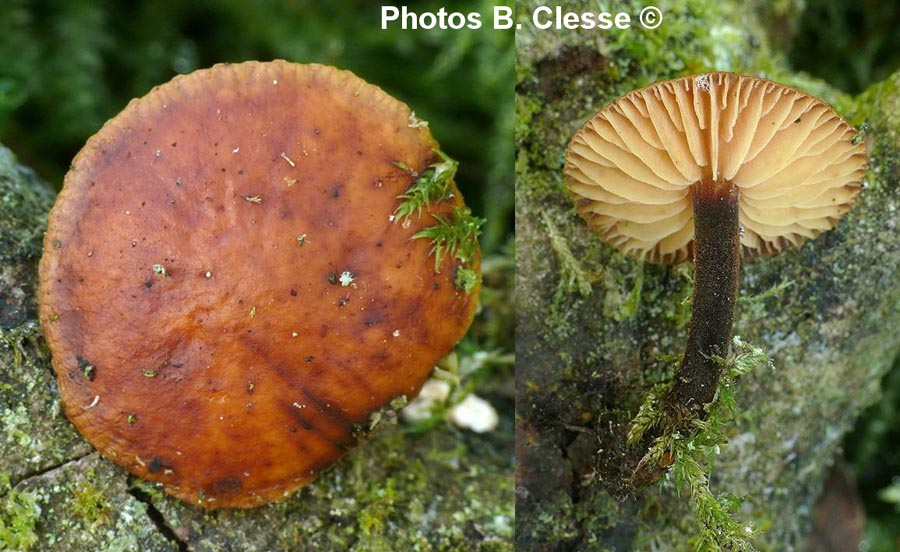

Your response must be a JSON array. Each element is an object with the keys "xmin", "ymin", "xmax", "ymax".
[{"xmin": 671, "ymin": 180, "xmax": 741, "ymax": 416}]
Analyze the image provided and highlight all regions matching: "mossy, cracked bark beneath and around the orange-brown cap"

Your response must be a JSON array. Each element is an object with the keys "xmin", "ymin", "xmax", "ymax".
[{"xmin": 0, "ymin": 146, "xmax": 513, "ymax": 552}]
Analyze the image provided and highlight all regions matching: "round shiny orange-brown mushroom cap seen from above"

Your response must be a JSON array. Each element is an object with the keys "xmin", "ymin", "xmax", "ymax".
[{"xmin": 40, "ymin": 61, "xmax": 479, "ymax": 508}]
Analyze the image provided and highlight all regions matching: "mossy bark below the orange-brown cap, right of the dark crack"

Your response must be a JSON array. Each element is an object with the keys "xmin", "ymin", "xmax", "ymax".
[{"xmin": 140, "ymin": 412, "xmax": 513, "ymax": 551}]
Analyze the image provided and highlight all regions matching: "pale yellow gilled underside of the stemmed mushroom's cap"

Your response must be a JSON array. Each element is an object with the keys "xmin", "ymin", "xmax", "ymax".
[{"xmin": 565, "ymin": 73, "xmax": 866, "ymax": 264}]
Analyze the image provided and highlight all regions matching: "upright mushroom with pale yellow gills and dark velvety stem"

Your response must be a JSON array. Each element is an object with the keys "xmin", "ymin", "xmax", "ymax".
[{"xmin": 565, "ymin": 73, "xmax": 866, "ymax": 416}]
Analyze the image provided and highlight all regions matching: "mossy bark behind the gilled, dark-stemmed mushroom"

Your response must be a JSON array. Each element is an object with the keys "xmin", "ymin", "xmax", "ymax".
[{"xmin": 516, "ymin": 0, "xmax": 900, "ymax": 551}]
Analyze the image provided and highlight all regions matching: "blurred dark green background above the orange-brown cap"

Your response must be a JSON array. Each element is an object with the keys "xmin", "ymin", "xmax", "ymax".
[{"xmin": 0, "ymin": 0, "xmax": 515, "ymax": 253}]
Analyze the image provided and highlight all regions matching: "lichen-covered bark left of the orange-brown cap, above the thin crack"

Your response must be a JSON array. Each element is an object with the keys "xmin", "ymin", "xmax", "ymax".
[{"xmin": 0, "ymin": 146, "xmax": 88, "ymax": 492}]
